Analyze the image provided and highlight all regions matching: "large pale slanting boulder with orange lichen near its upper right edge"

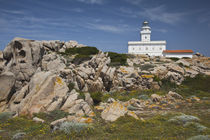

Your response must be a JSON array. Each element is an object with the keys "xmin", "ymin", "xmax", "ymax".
[{"xmin": 10, "ymin": 72, "xmax": 68, "ymax": 115}]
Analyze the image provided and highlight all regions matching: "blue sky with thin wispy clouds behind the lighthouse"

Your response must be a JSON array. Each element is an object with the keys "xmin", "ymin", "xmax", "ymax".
[{"xmin": 0, "ymin": 0, "xmax": 210, "ymax": 56}]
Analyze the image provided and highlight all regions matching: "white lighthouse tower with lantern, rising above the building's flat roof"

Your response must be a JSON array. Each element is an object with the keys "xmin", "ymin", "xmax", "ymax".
[{"xmin": 140, "ymin": 21, "xmax": 151, "ymax": 42}]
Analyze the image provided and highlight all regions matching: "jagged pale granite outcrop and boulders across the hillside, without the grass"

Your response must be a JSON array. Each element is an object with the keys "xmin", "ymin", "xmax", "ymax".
[{"xmin": 0, "ymin": 38, "xmax": 210, "ymax": 121}]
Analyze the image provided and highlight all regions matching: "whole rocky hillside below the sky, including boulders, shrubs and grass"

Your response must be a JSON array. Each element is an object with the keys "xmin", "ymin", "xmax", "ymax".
[{"xmin": 0, "ymin": 38, "xmax": 210, "ymax": 139}]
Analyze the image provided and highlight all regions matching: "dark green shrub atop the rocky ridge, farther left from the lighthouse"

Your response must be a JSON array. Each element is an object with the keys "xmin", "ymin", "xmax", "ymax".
[{"xmin": 65, "ymin": 46, "xmax": 99, "ymax": 55}]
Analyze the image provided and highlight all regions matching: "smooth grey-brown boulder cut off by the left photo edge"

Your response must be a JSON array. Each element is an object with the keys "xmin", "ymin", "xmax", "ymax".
[{"xmin": 0, "ymin": 72, "xmax": 15, "ymax": 102}]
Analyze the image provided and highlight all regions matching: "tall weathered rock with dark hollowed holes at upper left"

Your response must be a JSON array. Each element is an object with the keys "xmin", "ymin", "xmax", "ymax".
[{"xmin": 3, "ymin": 38, "xmax": 44, "ymax": 89}]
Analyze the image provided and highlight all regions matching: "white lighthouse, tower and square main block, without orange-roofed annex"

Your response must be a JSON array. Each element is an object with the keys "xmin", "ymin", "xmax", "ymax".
[{"xmin": 128, "ymin": 21, "xmax": 166, "ymax": 56}]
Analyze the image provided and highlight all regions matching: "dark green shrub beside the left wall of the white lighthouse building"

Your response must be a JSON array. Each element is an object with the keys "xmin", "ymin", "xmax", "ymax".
[{"xmin": 108, "ymin": 52, "xmax": 128, "ymax": 66}]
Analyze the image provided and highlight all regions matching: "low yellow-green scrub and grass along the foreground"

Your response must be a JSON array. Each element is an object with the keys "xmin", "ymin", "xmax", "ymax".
[{"xmin": 0, "ymin": 99, "xmax": 210, "ymax": 140}]
